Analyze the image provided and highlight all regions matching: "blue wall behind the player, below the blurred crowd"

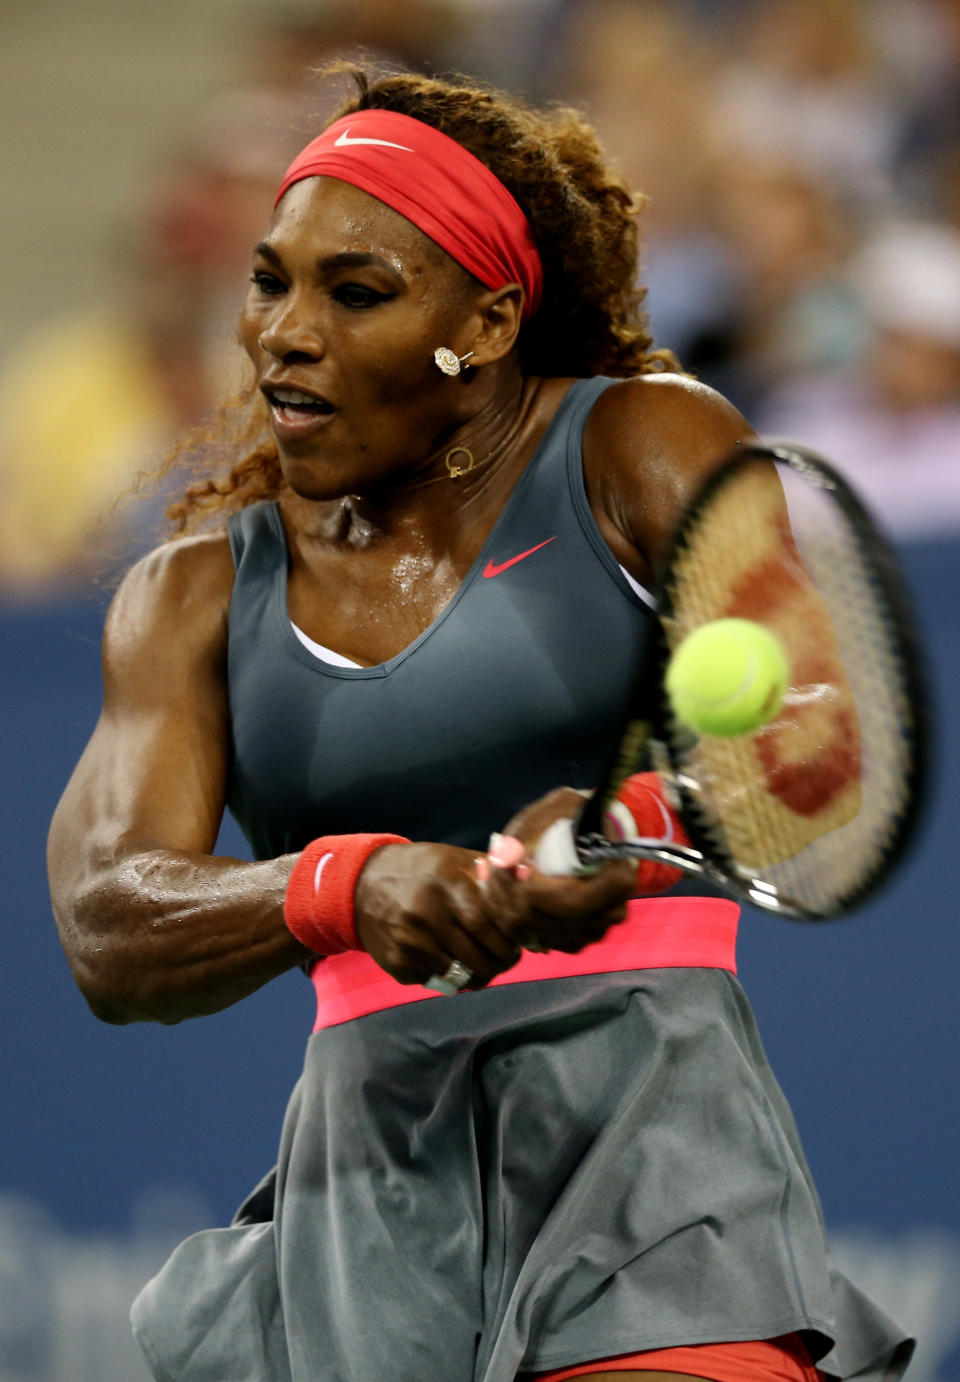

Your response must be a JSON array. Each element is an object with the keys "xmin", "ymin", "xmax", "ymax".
[{"xmin": 0, "ymin": 543, "xmax": 960, "ymax": 1382}]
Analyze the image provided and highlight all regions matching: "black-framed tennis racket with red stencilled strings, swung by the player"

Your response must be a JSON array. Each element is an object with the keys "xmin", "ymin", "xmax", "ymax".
[{"xmin": 535, "ymin": 442, "xmax": 927, "ymax": 920}]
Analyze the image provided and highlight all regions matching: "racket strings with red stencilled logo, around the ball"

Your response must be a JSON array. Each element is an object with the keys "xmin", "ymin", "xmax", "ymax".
[{"xmin": 664, "ymin": 462, "xmax": 917, "ymax": 914}]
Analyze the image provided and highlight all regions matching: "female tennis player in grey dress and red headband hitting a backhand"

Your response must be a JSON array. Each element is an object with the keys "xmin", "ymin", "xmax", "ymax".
[{"xmin": 50, "ymin": 75, "xmax": 910, "ymax": 1382}]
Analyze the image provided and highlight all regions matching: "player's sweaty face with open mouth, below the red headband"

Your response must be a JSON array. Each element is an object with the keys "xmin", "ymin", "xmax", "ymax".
[{"xmin": 240, "ymin": 177, "xmax": 482, "ymax": 499}]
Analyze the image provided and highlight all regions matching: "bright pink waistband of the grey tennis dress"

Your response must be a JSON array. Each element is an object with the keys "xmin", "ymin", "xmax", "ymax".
[{"xmin": 309, "ymin": 897, "xmax": 740, "ymax": 1031}]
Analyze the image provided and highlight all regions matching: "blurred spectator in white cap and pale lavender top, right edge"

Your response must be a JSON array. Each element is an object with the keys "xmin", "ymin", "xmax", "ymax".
[{"xmin": 756, "ymin": 223, "xmax": 960, "ymax": 538}]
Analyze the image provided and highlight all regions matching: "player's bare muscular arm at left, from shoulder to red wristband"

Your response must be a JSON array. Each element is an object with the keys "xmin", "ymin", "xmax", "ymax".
[{"xmin": 48, "ymin": 535, "xmax": 308, "ymax": 1023}]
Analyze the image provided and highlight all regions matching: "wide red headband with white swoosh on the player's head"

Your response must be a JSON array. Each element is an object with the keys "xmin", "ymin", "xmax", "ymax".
[{"xmin": 273, "ymin": 111, "xmax": 543, "ymax": 316}]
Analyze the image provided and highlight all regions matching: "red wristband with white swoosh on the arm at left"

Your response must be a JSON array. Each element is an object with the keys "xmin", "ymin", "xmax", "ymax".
[{"xmin": 283, "ymin": 835, "xmax": 410, "ymax": 955}]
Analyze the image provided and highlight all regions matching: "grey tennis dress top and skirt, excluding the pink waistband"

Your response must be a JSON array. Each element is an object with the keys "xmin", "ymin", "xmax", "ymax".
[{"xmin": 133, "ymin": 379, "xmax": 912, "ymax": 1382}]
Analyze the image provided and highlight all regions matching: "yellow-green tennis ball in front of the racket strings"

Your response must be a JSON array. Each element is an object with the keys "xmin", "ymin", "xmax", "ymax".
[{"xmin": 666, "ymin": 619, "xmax": 790, "ymax": 738}]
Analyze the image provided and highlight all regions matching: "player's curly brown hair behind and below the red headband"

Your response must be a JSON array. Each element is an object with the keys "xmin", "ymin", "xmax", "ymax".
[{"xmin": 161, "ymin": 64, "xmax": 680, "ymax": 532}]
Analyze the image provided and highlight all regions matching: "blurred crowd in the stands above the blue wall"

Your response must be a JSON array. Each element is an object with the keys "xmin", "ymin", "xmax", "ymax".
[{"xmin": 0, "ymin": 0, "xmax": 960, "ymax": 600}]
